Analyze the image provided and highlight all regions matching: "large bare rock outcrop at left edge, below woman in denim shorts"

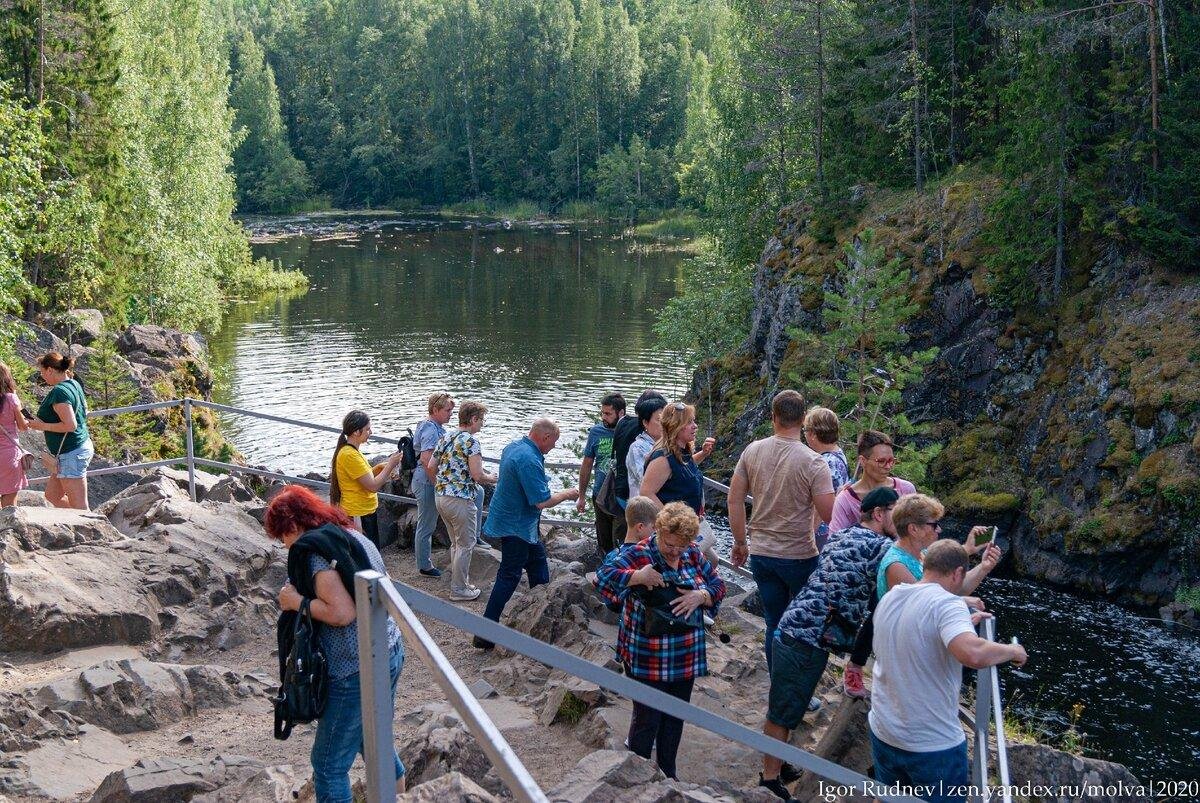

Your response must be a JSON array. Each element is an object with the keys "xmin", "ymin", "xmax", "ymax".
[{"xmin": 0, "ymin": 477, "xmax": 282, "ymax": 651}]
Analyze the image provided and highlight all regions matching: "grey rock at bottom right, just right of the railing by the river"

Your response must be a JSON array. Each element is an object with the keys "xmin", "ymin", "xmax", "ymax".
[{"xmin": 1008, "ymin": 744, "xmax": 1150, "ymax": 803}]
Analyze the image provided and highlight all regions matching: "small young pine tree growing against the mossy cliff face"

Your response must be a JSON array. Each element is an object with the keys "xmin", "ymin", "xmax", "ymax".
[{"xmin": 786, "ymin": 229, "xmax": 941, "ymax": 483}]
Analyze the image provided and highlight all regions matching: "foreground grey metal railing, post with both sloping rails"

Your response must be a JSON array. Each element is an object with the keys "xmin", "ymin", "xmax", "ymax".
[{"xmin": 354, "ymin": 571, "xmax": 917, "ymax": 803}]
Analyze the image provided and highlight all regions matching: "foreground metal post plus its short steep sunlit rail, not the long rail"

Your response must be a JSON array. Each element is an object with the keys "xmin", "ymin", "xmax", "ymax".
[{"xmin": 354, "ymin": 571, "xmax": 548, "ymax": 803}]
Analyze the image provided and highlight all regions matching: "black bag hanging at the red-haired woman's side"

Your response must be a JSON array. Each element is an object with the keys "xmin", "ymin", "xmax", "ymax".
[{"xmin": 271, "ymin": 599, "xmax": 329, "ymax": 741}]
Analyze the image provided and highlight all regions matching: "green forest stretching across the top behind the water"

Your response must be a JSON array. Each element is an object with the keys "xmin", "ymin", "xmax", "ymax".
[{"xmin": 0, "ymin": 0, "xmax": 1200, "ymax": 328}]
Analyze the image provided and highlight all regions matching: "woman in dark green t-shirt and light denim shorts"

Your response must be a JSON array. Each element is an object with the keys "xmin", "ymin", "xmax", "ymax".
[{"xmin": 29, "ymin": 352, "xmax": 96, "ymax": 510}]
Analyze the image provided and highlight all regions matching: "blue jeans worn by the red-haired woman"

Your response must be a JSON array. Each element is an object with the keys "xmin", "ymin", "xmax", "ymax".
[{"xmin": 312, "ymin": 646, "xmax": 404, "ymax": 803}]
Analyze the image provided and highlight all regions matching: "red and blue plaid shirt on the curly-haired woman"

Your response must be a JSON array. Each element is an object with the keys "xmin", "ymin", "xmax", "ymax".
[{"xmin": 596, "ymin": 535, "xmax": 725, "ymax": 681}]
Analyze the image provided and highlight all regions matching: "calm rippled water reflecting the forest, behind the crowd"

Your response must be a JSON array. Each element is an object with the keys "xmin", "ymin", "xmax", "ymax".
[{"xmin": 212, "ymin": 221, "xmax": 686, "ymax": 471}]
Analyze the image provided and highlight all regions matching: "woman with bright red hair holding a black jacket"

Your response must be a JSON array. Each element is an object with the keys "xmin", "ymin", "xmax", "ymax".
[{"xmin": 263, "ymin": 485, "xmax": 404, "ymax": 803}]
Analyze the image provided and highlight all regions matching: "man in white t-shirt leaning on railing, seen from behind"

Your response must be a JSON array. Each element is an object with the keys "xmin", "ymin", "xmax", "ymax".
[{"xmin": 869, "ymin": 539, "xmax": 1028, "ymax": 803}]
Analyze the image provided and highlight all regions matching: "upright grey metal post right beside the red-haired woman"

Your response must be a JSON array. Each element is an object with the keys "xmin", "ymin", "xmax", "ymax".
[{"xmin": 354, "ymin": 573, "xmax": 396, "ymax": 803}]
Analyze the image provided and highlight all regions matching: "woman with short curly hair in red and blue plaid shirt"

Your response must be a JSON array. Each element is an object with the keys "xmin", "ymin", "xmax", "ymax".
[{"xmin": 596, "ymin": 502, "xmax": 725, "ymax": 778}]
